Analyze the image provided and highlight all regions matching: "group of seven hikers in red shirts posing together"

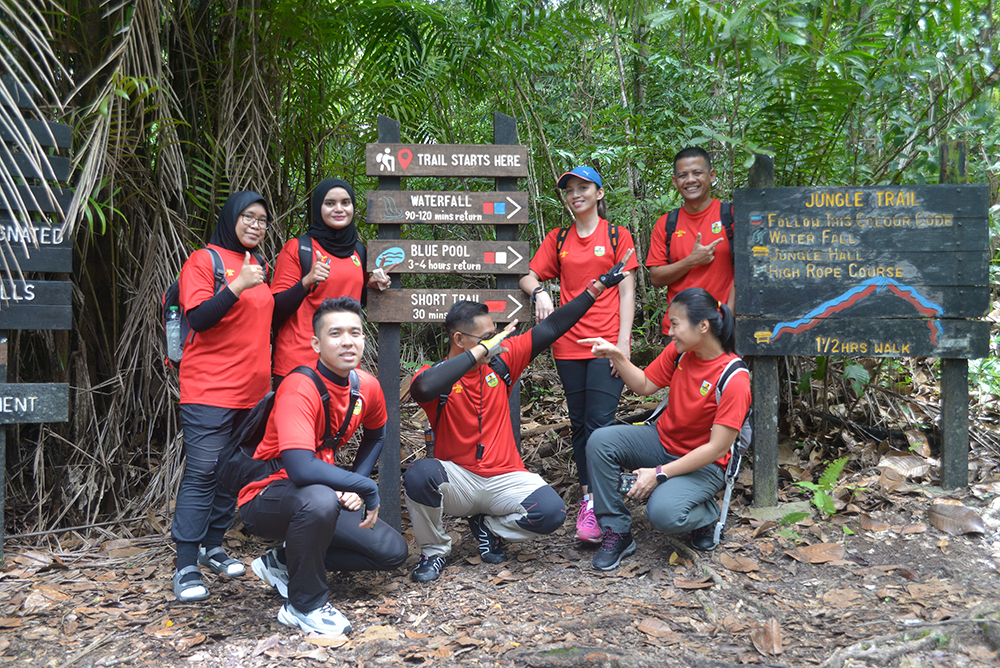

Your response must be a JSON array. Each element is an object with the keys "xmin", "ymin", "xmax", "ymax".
[{"xmin": 172, "ymin": 148, "xmax": 750, "ymax": 634}]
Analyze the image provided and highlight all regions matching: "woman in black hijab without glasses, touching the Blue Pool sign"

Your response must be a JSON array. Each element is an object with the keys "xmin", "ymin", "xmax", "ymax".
[{"xmin": 271, "ymin": 179, "xmax": 389, "ymax": 379}]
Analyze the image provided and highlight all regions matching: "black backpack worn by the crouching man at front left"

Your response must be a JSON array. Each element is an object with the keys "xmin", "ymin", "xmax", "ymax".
[{"xmin": 215, "ymin": 366, "xmax": 361, "ymax": 496}]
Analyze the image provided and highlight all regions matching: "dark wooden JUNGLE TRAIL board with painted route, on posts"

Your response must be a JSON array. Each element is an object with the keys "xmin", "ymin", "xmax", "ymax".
[{"xmin": 733, "ymin": 170, "xmax": 990, "ymax": 506}]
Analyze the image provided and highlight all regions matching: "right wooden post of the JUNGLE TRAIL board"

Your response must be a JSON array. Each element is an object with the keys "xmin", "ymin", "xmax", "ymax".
[{"xmin": 939, "ymin": 142, "xmax": 969, "ymax": 489}]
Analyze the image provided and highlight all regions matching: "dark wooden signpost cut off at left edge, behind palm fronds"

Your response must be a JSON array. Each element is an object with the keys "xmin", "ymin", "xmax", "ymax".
[{"xmin": 0, "ymin": 77, "xmax": 73, "ymax": 558}]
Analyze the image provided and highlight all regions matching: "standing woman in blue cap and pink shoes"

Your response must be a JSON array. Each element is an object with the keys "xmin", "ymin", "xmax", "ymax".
[{"xmin": 520, "ymin": 167, "xmax": 638, "ymax": 543}]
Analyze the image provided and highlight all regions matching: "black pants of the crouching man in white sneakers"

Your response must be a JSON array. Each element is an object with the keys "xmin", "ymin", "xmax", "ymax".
[{"xmin": 240, "ymin": 480, "xmax": 408, "ymax": 612}]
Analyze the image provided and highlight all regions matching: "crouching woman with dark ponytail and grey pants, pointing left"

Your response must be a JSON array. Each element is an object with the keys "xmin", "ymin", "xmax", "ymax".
[{"xmin": 580, "ymin": 288, "xmax": 750, "ymax": 571}]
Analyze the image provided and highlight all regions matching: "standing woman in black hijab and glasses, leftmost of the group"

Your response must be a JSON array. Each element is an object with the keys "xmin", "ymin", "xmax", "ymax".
[{"xmin": 171, "ymin": 191, "xmax": 274, "ymax": 601}]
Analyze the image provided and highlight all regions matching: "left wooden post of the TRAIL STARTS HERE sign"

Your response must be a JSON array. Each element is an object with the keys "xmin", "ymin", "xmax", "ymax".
[{"xmin": 378, "ymin": 116, "xmax": 403, "ymax": 532}]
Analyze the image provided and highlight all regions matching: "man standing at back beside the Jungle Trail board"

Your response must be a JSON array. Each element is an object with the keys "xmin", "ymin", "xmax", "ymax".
[{"xmin": 646, "ymin": 146, "xmax": 736, "ymax": 334}]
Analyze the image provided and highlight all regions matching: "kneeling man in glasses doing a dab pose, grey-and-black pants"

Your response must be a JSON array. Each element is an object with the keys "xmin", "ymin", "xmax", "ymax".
[{"xmin": 403, "ymin": 258, "xmax": 628, "ymax": 582}]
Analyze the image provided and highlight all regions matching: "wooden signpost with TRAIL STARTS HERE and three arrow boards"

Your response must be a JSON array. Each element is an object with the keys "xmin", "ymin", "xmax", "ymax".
[{"xmin": 365, "ymin": 113, "xmax": 531, "ymax": 530}]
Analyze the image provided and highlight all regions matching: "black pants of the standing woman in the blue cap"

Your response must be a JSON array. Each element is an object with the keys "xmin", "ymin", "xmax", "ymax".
[{"xmin": 556, "ymin": 358, "xmax": 625, "ymax": 487}]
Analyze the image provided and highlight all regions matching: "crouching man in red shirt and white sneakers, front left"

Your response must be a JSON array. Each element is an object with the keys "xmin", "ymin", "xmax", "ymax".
[{"xmin": 239, "ymin": 297, "xmax": 408, "ymax": 635}]
